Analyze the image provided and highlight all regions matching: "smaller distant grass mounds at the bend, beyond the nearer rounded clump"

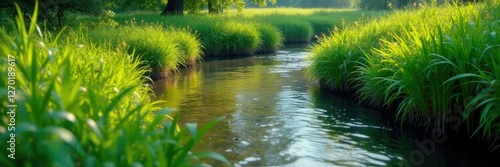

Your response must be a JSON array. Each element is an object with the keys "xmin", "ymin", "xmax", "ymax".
[{"xmin": 115, "ymin": 8, "xmax": 383, "ymax": 56}]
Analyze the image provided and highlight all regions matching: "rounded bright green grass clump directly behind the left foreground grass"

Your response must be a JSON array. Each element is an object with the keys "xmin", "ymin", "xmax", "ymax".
[{"xmin": 88, "ymin": 24, "xmax": 202, "ymax": 78}]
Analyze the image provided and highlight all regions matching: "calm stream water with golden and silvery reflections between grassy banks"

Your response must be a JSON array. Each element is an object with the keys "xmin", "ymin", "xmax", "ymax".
[{"xmin": 154, "ymin": 45, "xmax": 500, "ymax": 167}]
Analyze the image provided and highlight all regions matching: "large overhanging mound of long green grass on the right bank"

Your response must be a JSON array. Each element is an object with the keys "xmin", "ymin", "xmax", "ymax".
[{"xmin": 307, "ymin": 0, "xmax": 500, "ymax": 149}]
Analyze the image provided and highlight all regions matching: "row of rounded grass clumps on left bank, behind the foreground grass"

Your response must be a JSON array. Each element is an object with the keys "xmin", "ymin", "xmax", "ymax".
[{"xmin": 77, "ymin": 8, "xmax": 385, "ymax": 79}]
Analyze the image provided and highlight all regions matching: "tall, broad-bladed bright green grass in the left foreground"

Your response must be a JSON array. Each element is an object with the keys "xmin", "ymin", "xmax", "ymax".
[{"xmin": 0, "ymin": 4, "xmax": 229, "ymax": 166}]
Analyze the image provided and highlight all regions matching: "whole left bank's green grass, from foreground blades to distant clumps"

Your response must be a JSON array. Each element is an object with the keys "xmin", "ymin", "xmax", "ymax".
[{"xmin": 0, "ymin": 1, "xmax": 386, "ymax": 166}]
